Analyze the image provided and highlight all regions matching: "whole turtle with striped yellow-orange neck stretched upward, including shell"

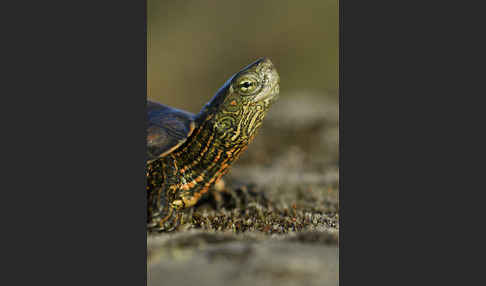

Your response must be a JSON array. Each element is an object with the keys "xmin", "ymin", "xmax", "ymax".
[{"xmin": 146, "ymin": 58, "xmax": 280, "ymax": 232}]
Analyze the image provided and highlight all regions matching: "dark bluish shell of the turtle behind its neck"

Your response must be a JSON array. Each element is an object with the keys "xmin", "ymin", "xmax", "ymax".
[{"xmin": 147, "ymin": 101, "xmax": 195, "ymax": 162}]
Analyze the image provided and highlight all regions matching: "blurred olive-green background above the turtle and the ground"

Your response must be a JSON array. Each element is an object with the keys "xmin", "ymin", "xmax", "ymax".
[{"xmin": 147, "ymin": 0, "xmax": 339, "ymax": 112}]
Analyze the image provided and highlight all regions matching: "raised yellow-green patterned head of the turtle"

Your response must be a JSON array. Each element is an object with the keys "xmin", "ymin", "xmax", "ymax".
[{"xmin": 199, "ymin": 58, "xmax": 280, "ymax": 144}]
